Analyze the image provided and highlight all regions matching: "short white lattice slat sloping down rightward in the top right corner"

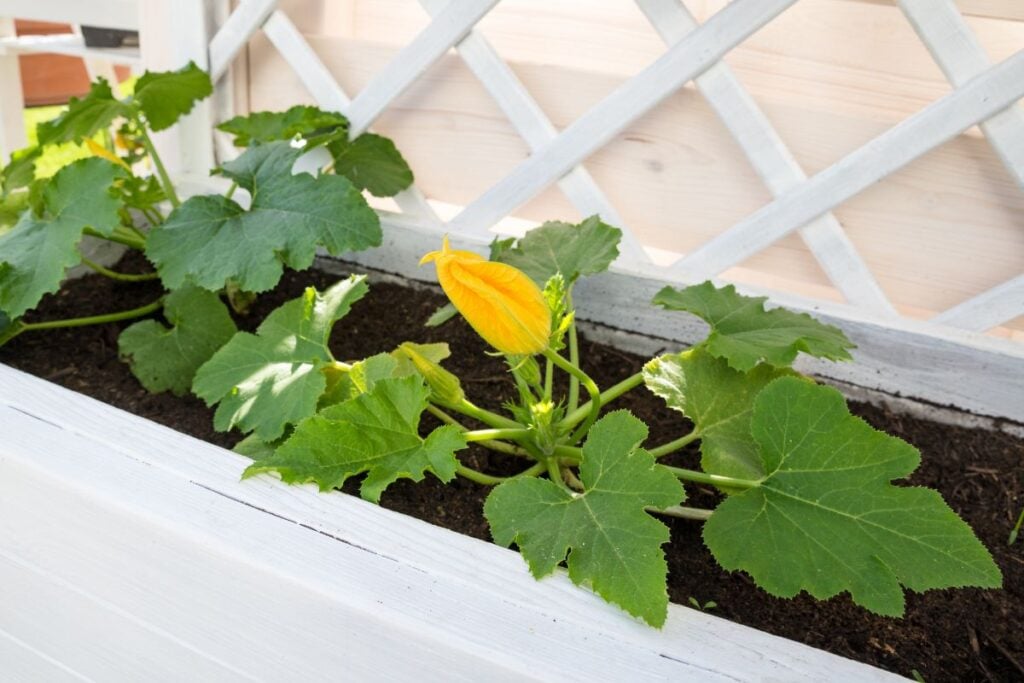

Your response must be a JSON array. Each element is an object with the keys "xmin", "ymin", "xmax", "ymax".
[{"xmin": 899, "ymin": 0, "xmax": 1024, "ymax": 188}]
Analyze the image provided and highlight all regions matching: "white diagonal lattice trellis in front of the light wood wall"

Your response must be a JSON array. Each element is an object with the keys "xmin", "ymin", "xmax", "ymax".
[{"xmin": 151, "ymin": 0, "xmax": 1024, "ymax": 419}]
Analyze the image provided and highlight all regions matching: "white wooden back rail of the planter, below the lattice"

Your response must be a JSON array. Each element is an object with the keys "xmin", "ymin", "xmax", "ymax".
[{"xmin": 346, "ymin": 215, "xmax": 1024, "ymax": 423}]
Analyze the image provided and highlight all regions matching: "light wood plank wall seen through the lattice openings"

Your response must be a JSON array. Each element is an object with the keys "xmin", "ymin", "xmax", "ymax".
[{"xmin": 239, "ymin": 0, "xmax": 1024, "ymax": 339}]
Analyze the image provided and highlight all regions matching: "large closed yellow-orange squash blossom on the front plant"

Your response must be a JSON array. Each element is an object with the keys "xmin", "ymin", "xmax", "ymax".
[{"xmin": 420, "ymin": 237, "xmax": 551, "ymax": 355}]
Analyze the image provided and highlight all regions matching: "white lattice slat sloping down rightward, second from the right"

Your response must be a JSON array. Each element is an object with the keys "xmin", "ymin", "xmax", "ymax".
[{"xmin": 637, "ymin": 0, "xmax": 896, "ymax": 315}]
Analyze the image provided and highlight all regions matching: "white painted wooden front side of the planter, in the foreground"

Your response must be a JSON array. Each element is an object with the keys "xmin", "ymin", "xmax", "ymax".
[{"xmin": 0, "ymin": 365, "xmax": 897, "ymax": 681}]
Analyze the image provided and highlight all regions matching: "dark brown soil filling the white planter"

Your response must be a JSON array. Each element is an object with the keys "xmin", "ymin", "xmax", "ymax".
[{"xmin": 0, "ymin": 253, "xmax": 1024, "ymax": 682}]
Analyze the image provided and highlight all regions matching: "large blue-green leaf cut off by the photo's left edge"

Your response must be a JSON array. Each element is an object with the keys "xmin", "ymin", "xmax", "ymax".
[{"xmin": 0, "ymin": 159, "xmax": 124, "ymax": 317}]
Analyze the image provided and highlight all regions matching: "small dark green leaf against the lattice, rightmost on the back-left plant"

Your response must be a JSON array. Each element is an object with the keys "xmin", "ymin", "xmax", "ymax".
[{"xmin": 330, "ymin": 133, "xmax": 413, "ymax": 197}]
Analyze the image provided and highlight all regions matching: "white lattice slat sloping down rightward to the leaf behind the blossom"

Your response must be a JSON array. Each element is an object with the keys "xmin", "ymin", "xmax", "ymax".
[{"xmin": 420, "ymin": 0, "xmax": 649, "ymax": 263}]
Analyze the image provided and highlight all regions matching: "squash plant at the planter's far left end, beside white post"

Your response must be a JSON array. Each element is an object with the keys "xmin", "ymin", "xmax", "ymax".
[{"xmin": 0, "ymin": 69, "xmax": 413, "ymax": 394}]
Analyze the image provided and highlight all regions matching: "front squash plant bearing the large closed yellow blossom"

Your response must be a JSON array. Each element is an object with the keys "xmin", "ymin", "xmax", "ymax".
[{"xmin": 186, "ymin": 218, "xmax": 1001, "ymax": 626}]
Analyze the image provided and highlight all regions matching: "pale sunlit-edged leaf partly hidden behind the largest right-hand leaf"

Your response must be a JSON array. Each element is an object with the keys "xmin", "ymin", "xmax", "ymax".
[{"xmin": 643, "ymin": 347, "xmax": 790, "ymax": 479}]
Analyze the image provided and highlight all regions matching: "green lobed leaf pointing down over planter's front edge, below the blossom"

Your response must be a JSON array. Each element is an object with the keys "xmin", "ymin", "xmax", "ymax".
[{"xmin": 483, "ymin": 411, "xmax": 684, "ymax": 627}]
